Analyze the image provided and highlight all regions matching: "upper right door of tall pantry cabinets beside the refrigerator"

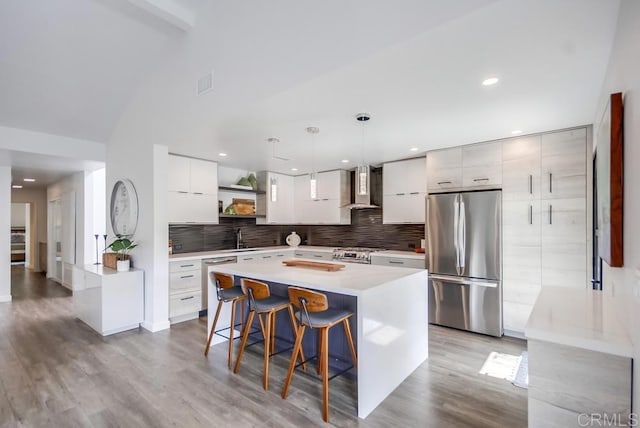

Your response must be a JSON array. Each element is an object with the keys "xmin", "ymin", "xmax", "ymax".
[{"xmin": 541, "ymin": 128, "xmax": 587, "ymax": 199}]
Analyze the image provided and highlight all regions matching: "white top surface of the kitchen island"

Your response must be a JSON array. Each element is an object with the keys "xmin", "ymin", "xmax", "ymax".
[{"xmin": 209, "ymin": 258, "xmax": 427, "ymax": 296}]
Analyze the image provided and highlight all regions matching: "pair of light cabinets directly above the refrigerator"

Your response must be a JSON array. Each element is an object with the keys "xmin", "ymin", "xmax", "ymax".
[{"xmin": 427, "ymin": 141, "xmax": 502, "ymax": 193}]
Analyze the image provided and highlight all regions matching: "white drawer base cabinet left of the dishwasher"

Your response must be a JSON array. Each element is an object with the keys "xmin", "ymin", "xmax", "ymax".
[{"xmin": 169, "ymin": 260, "xmax": 202, "ymax": 324}]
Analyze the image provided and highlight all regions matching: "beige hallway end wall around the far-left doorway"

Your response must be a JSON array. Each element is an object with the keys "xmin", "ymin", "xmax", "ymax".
[{"xmin": 11, "ymin": 188, "xmax": 47, "ymax": 272}]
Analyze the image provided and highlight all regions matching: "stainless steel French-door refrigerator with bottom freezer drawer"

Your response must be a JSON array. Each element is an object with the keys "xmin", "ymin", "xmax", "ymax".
[{"xmin": 426, "ymin": 190, "xmax": 502, "ymax": 336}]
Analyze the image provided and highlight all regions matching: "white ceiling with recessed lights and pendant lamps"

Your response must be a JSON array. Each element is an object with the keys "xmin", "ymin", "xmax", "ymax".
[{"xmin": 0, "ymin": 0, "xmax": 618, "ymax": 179}]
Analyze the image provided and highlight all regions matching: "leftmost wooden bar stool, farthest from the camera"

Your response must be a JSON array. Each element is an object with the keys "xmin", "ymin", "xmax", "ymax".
[{"xmin": 204, "ymin": 272, "xmax": 247, "ymax": 368}]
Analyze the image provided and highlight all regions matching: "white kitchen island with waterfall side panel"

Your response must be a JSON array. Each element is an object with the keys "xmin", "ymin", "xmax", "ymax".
[{"xmin": 208, "ymin": 259, "xmax": 428, "ymax": 418}]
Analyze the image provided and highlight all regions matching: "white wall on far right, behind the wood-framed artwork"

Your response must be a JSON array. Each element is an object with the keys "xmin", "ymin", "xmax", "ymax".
[{"xmin": 594, "ymin": 0, "xmax": 640, "ymax": 411}]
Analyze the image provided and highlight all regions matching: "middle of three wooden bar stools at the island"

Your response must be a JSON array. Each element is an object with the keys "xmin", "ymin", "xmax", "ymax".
[{"xmin": 233, "ymin": 278, "xmax": 304, "ymax": 389}]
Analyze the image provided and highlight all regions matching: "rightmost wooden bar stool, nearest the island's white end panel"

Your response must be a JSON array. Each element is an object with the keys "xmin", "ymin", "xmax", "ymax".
[{"xmin": 282, "ymin": 287, "xmax": 358, "ymax": 422}]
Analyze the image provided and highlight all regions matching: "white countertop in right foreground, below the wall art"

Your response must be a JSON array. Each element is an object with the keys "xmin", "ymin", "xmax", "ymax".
[{"xmin": 525, "ymin": 287, "xmax": 633, "ymax": 358}]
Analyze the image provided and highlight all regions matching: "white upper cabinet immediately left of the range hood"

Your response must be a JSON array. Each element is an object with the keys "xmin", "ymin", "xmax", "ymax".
[{"xmin": 294, "ymin": 170, "xmax": 351, "ymax": 224}]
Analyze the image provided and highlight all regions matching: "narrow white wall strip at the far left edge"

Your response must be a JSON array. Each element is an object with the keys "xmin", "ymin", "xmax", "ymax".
[{"xmin": 0, "ymin": 166, "xmax": 11, "ymax": 302}]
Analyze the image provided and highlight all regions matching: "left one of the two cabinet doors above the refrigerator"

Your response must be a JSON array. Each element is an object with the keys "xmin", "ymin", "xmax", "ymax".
[{"xmin": 427, "ymin": 147, "xmax": 462, "ymax": 193}]
